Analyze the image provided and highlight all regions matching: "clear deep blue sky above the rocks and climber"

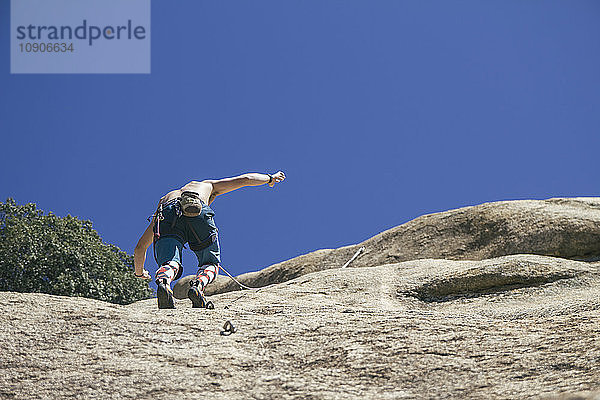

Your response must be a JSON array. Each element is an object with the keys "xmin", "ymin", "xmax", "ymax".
[{"xmin": 0, "ymin": 0, "xmax": 600, "ymax": 274}]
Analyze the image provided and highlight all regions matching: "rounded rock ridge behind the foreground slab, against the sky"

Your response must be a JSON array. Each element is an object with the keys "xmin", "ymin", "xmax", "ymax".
[{"xmin": 195, "ymin": 197, "xmax": 600, "ymax": 298}]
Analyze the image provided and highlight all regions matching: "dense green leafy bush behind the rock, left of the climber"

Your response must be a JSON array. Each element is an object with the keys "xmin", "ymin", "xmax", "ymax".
[{"xmin": 0, "ymin": 198, "xmax": 152, "ymax": 304}]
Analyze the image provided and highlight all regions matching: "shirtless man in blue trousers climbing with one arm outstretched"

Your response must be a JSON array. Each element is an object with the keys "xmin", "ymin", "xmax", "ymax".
[{"xmin": 133, "ymin": 171, "xmax": 285, "ymax": 308}]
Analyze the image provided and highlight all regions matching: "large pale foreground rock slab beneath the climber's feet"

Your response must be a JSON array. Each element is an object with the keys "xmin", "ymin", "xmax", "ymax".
[{"xmin": 0, "ymin": 255, "xmax": 600, "ymax": 399}]
